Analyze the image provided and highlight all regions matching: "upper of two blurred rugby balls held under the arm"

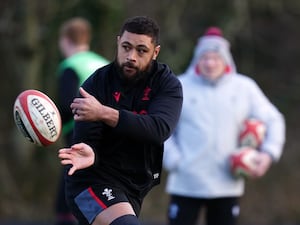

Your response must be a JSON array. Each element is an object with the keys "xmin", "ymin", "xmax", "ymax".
[{"xmin": 239, "ymin": 118, "xmax": 266, "ymax": 149}]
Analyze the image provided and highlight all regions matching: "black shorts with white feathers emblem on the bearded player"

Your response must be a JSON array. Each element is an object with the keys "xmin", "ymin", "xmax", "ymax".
[{"xmin": 68, "ymin": 185, "xmax": 142, "ymax": 225}]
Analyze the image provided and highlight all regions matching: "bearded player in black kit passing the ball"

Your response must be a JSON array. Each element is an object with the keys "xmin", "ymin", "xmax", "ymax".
[{"xmin": 58, "ymin": 16, "xmax": 182, "ymax": 225}]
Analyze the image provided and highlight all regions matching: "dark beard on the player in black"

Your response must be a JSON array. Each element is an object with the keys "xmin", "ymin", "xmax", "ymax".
[{"xmin": 115, "ymin": 59, "xmax": 153, "ymax": 82}]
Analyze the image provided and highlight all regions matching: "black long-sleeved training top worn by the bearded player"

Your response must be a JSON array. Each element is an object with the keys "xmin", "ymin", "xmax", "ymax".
[{"xmin": 67, "ymin": 61, "xmax": 183, "ymax": 198}]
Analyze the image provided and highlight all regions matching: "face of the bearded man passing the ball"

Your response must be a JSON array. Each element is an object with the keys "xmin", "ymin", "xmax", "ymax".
[{"xmin": 117, "ymin": 31, "xmax": 160, "ymax": 79}]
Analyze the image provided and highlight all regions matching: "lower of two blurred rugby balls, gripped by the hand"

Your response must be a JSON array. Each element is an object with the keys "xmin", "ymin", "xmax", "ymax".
[{"xmin": 230, "ymin": 146, "xmax": 259, "ymax": 178}]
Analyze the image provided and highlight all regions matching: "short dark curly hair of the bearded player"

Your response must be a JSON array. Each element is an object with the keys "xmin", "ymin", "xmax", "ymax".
[{"xmin": 119, "ymin": 16, "xmax": 160, "ymax": 45}]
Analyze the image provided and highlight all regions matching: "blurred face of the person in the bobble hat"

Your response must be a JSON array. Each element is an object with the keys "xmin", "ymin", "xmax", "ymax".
[{"xmin": 197, "ymin": 51, "xmax": 226, "ymax": 81}]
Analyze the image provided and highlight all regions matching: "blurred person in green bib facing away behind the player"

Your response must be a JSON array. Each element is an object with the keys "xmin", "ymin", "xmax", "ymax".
[{"xmin": 55, "ymin": 17, "xmax": 109, "ymax": 225}]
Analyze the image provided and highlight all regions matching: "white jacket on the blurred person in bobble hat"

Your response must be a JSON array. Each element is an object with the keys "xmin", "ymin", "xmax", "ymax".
[{"xmin": 163, "ymin": 70, "xmax": 285, "ymax": 198}]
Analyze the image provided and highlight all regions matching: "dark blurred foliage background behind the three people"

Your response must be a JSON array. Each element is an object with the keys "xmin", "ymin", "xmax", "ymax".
[{"xmin": 0, "ymin": 0, "xmax": 300, "ymax": 225}]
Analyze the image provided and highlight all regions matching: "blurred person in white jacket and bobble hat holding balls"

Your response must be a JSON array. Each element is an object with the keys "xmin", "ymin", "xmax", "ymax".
[{"xmin": 163, "ymin": 27, "xmax": 285, "ymax": 225}]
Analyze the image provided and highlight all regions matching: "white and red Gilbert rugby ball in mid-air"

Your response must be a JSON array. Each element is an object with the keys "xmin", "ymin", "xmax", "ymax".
[{"xmin": 13, "ymin": 90, "xmax": 62, "ymax": 146}]
